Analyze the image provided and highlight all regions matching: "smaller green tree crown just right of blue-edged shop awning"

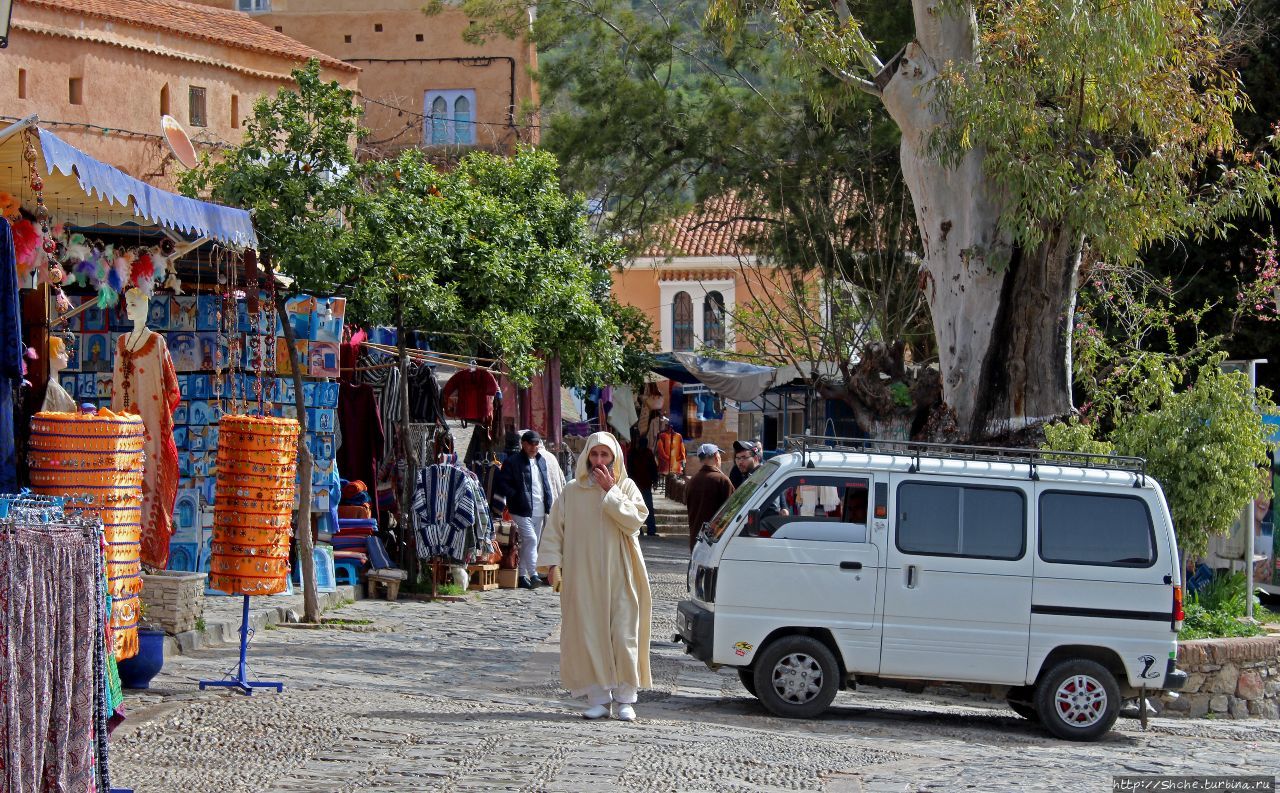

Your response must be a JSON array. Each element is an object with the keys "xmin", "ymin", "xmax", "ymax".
[{"xmin": 179, "ymin": 60, "xmax": 361, "ymax": 293}]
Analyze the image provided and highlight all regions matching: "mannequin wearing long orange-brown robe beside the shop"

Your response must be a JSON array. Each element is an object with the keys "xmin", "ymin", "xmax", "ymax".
[{"xmin": 111, "ymin": 288, "xmax": 182, "ymax": 569}]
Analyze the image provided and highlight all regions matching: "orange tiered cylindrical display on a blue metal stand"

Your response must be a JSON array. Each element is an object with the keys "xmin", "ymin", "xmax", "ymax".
[{"xmin": 209, "ymin": 416, "xmax": 298, "ymax": 595}]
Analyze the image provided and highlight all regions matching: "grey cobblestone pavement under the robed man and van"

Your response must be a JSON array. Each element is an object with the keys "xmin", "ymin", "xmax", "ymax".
[{"xmin": 111, "ymin": 509, "xmax": 1280, "ymax": 793}]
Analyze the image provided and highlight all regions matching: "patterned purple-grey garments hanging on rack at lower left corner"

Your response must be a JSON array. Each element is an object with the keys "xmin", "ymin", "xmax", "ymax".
[{"xmin": 0, "ymin": 517, "xmax": 110, "ymax": 793}]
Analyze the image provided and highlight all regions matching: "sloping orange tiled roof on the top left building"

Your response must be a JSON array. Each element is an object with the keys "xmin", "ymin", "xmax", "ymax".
[{"xmin": 17, "ymin": 0, "xmax": 360, "ymax": 72}]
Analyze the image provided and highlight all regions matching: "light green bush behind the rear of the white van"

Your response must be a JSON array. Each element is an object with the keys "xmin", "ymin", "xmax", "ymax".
[{"xmin": 1044, "ymin": 356, "xmax": 1275, "ymax": 559}]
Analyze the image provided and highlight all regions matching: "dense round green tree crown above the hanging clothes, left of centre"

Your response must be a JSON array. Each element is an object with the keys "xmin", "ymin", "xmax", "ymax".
[{"xmin": 353, "ymin": 148, "xmax": 652, "ymax": 385}]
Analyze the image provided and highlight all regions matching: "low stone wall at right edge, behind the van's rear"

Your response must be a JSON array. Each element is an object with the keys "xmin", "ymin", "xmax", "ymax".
[{"xmin": 1158, "ymin": 636, "xmax": 1280, "ymax": 719}]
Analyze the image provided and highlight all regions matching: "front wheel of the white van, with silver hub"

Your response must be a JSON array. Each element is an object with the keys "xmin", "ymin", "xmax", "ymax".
[{"xmin": 754, "ymin": 636, "xmax": 840, "ymax": 719}]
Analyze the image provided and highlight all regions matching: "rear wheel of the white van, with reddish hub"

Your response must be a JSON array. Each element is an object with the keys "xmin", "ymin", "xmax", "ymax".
[{"xmin": 1036, "ymin": 659, "xmax": 1120, "ymax": 741}]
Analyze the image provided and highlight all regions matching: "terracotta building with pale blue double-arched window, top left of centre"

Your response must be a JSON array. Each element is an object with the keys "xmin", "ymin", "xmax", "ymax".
[{"xmin": 189, "ymin": 0, "xmax": 536, "ymax": 157}]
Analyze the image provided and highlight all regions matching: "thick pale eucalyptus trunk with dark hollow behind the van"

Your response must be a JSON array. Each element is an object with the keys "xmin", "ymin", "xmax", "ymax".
[{"xmin": 882, "ymin": 0, "xmax": 1082, "ymax": 439}]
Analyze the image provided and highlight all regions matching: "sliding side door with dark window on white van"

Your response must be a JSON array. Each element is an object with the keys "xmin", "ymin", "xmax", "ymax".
[{"xmin": 881, "ymin": 475, "xmax": 1032, "ymax": 684}]
